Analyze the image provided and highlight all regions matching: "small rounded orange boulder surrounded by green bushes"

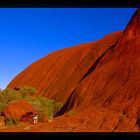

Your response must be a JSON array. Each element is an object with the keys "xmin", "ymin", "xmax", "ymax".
[{"xmin": 2, "ymin": 100, "xmax": 35, "ymax": 119}]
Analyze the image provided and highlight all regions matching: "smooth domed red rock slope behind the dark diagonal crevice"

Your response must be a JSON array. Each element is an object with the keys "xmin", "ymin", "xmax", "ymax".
[{"xmin": 8, "ymin": 32, "xmax": 121, "ymax": 103}]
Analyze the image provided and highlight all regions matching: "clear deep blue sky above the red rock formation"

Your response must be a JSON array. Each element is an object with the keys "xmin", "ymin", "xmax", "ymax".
[{"xmin": 0, "ymin": 8, "xmax": 136, "ymax": 89}]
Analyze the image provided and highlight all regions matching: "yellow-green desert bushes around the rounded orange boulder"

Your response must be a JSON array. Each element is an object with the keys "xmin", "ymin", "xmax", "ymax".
[{"xmin": 0, "ymin": 86, "xmax": 63, "ymax": 125}]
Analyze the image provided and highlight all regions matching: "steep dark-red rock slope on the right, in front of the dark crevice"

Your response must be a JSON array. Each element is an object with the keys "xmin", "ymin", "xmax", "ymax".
[{"xmin": 67, "ymin": 9, "xmax": 140, "ymax": 131}]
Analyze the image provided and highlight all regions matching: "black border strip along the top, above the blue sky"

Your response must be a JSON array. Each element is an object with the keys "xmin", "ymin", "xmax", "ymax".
[{"xmin": 0, "ymin": 0, "xmax": 140, "ymax": 8}]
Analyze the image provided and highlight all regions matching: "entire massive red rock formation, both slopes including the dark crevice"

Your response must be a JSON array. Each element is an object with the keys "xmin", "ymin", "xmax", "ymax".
[{"xmin": 8, "ymin": 9, "xmax": 140, "ymax": 131}]
